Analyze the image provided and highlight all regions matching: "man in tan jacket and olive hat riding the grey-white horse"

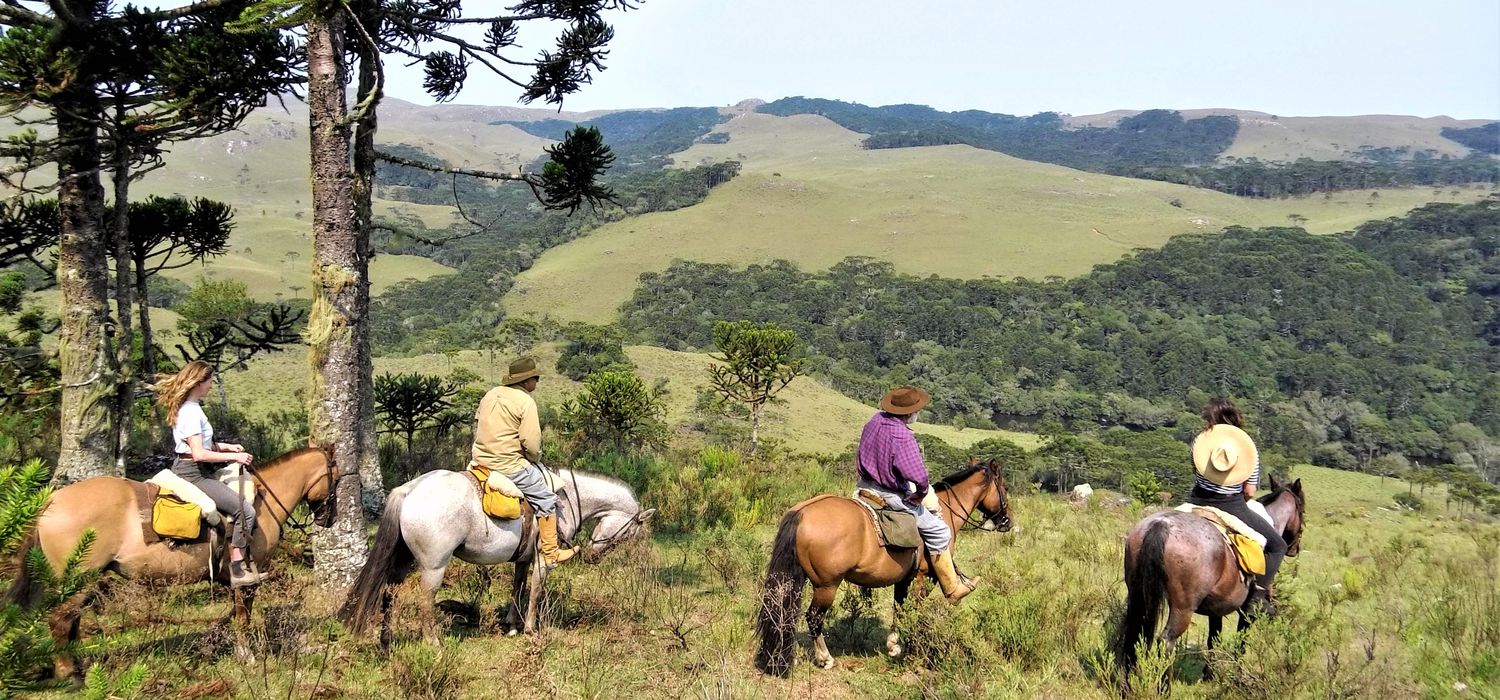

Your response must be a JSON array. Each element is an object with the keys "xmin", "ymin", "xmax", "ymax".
[{"xmin": 473, "ymin": 357, "xmax": 576, "ymax": 567}]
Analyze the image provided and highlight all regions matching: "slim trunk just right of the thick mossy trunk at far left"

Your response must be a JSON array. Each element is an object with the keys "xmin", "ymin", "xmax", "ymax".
[{"xmin": 114, "ymin": 126, "xmax": 135, "ymax": 475}]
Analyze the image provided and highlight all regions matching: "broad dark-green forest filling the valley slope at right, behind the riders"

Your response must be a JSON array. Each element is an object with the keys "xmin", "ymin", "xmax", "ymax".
[{"xmin": 624, "ymin": 199, "xmax": 1500, "ymax": 478}]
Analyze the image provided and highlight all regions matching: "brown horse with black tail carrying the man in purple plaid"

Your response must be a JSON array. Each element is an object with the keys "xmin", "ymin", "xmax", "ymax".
[{"xmin": 755, "ymin": 460, "xmax": 1011, "ymax": 676}]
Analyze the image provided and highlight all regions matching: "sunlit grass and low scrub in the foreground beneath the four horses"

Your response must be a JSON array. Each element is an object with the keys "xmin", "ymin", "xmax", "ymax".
[{"xmin": 26, "ymin": 463, "xmax": 1500, "ymax": 700}]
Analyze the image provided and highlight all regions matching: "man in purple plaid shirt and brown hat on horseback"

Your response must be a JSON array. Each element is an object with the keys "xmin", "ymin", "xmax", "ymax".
[{"xmin": 858, "ymin": 387, "xmax": 980, "ymax": 601}]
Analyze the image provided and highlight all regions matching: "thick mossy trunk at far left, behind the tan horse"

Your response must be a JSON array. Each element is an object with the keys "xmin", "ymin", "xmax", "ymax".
[{"xmin": 53, "ymin": 72, "xmax": 116, "ymax": 484}]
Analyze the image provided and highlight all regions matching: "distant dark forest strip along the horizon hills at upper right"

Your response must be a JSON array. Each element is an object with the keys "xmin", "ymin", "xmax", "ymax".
[{"xmin": 759, "ymin": 97, "xmax": 1500, "ymax": 196}]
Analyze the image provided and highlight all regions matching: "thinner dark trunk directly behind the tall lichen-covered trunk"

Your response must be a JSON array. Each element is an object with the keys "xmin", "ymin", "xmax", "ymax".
[{"xmin": 354, "ymin": 12, "xmax": 387, "ymax": 517}]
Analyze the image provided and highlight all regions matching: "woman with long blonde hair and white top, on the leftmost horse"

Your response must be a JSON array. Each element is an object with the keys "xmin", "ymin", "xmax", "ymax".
[{"xmin": 156, "ymin": 360, "xmax": 266, "ymax": 586}]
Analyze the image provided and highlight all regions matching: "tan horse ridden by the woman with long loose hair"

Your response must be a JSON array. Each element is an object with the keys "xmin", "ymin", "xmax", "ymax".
[{"xmin": 6, "ymin": 447, "xmax": 339, "ymax": 678}]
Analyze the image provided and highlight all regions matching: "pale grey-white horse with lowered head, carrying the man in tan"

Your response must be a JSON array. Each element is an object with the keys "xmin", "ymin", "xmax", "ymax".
[{"xmin": 339, "ymin": 469, "xmax": 656, "ymax": 645}]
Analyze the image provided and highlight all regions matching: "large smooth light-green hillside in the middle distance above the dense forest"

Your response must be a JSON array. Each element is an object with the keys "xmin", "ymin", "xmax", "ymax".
[{"xmin": 507, "ymin": 114, "xmax": 1484, "ymax": 321}]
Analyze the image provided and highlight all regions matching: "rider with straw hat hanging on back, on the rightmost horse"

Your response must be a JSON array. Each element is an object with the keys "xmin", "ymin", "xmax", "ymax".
[{"xmin": 1188, "ymin": 399, "xmax": 1287, "ymax": 615}]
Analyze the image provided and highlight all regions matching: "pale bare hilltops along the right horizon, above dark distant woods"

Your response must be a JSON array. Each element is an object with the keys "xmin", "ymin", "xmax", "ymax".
[{"xmin": 1068, "ymin": 109, "xmax": 1490, "ymax": 160}]
